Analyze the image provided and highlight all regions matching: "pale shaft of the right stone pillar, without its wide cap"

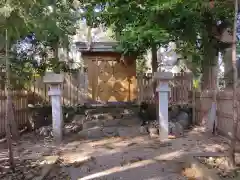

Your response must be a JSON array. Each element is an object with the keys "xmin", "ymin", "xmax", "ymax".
[{"xmin": 156, "ymin": 82, "xmax": 170, "ymax": 140}]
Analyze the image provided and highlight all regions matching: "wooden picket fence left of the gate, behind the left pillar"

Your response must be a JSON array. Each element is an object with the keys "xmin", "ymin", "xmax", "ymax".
[{"xmin": 0, "ymin": 71, "xmax": 88, "ymax": 137}]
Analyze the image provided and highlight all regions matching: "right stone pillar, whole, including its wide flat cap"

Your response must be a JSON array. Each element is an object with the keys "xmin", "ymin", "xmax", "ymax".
[{"xmin": 154, "ymin": 72, "xmax": 173, "ymax": 141}]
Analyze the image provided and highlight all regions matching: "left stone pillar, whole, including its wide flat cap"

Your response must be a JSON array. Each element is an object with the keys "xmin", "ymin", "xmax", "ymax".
[{"xmin": 43, "ymin": 73, "xmax": 64, "ymax": 143}]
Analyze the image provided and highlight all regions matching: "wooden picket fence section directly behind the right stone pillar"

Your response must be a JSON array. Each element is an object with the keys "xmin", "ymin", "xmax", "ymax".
[{"xmin": 137, "ymin": 72, "xmax": 192, "ymax": 105}]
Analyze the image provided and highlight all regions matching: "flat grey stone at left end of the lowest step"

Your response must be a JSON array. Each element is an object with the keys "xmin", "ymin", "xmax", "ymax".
[{"xmin": 78, "ymin": 127, "xmax": 104, "ymax": 139}]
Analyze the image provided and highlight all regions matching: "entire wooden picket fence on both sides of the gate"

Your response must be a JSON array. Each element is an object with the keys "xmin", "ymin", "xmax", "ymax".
[{"xmin": 7, "ymin": 69, "xmax": 240, "ymax": 138}]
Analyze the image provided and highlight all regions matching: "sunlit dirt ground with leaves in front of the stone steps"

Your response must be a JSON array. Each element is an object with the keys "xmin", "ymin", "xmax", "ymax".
[{"xmin": 0, "ymin": 126, "xmax": 232, "ymax": 180}]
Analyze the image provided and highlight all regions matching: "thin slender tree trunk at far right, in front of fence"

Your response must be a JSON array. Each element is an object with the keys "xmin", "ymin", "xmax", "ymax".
[{"xmin": 230, "ymin": 0, "xmax": 238, "ymax": 168}]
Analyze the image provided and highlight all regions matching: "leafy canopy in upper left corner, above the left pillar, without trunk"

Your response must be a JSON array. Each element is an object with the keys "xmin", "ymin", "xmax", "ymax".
[{"xmin": 0, "ymin": 0, "xmax": 79, "ymax": 88}]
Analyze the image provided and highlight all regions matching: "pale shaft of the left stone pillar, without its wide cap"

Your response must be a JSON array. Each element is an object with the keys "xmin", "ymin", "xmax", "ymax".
[{"xmin": 48, "ymin": 85, "xmax": 63, "ymax": 142}]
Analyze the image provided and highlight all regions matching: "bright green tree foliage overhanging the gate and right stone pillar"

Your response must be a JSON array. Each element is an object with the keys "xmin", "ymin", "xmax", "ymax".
[{"xmin": 83, "ymin": 0, "xmax": 233, "ymax": 87}]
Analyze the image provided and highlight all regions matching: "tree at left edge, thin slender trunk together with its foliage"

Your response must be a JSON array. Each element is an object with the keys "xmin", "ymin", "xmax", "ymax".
[{"xmin": 0, "ymin": 0, "xmax": 78, "ymax": 169}]
